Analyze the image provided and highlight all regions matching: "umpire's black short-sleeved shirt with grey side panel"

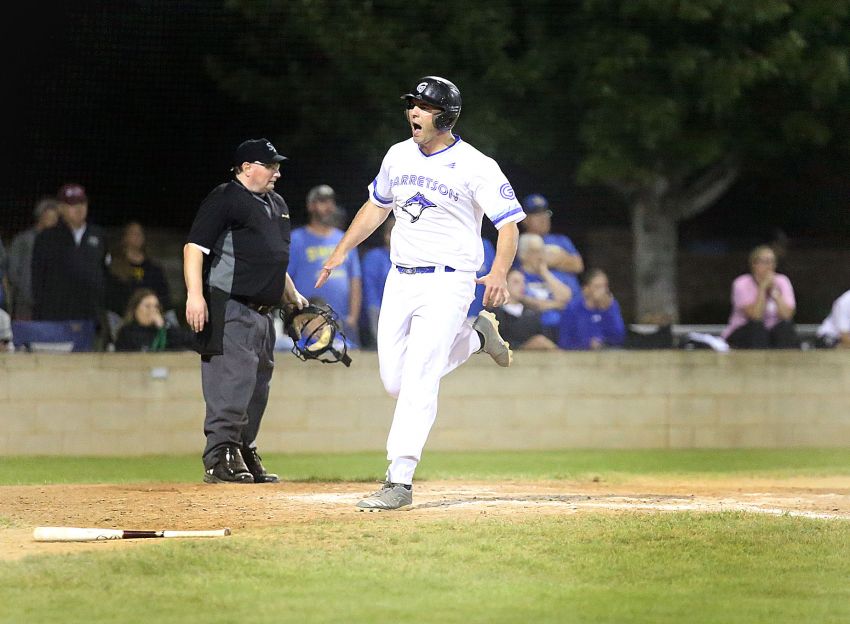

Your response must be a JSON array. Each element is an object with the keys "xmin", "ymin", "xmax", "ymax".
[{"xmin": 188, "ymin": 180, "xmax": 290, "ymax": 305}]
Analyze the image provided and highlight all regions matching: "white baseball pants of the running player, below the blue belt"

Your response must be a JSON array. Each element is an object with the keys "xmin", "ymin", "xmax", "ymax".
[{"xmin": 378, "ymin": 266, "xmax": 481, "ymax": 484}]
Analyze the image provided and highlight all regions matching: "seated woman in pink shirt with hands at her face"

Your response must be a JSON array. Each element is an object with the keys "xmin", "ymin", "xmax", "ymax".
[{"xmin": 722, "ymin": 245, "xmax": 800, "ymax": 349}]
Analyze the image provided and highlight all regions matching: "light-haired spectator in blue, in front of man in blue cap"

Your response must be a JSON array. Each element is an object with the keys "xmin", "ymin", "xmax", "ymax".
[{"xmin": 517, "ymin": 232, "xmax": 573, "ymax": 343}]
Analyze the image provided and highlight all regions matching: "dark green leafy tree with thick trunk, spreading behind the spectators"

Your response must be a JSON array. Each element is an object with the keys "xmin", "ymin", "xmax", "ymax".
[{"xmin": 210, "ymin": 0, "xmax": 850, "ymax": 317}]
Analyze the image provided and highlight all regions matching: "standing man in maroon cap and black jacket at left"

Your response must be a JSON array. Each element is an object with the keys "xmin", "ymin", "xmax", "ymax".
[{"xmin": 32, "ymin": 184, "xmax": 109, "ymax": 324}]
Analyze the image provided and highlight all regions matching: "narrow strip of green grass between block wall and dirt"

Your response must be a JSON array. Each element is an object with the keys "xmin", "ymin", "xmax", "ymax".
[{"xmin": 0, "ymin": 449, "xmax": 850, "ymax": 485}]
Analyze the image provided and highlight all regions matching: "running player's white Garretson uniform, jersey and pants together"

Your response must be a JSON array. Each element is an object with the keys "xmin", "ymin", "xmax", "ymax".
[{"xmin": 369, "ymin": 135, "xmax": 525, "ymax": 484}]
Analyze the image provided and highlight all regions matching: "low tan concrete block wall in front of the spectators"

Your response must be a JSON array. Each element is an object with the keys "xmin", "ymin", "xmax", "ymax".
[{"xmin": 0, "ymin": 351, "xmax": 850, "ymax": 455}]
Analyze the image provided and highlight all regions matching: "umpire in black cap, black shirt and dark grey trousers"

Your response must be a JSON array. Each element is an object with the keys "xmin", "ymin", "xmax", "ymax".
[{"xmin": 183, "ymin": 139, "xmax": 307, "ymax": 483}]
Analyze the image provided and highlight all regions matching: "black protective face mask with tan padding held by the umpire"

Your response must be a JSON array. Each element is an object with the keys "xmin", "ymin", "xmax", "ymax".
[{"xmin": 280, "ymin": 304, "xmax": 351, "ymax": 366}]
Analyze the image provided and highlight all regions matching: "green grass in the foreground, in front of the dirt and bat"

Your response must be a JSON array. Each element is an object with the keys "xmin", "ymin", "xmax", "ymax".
[{"xmin": 0, "ymin": 513, "xmax": 850, "ymax": 624}]
